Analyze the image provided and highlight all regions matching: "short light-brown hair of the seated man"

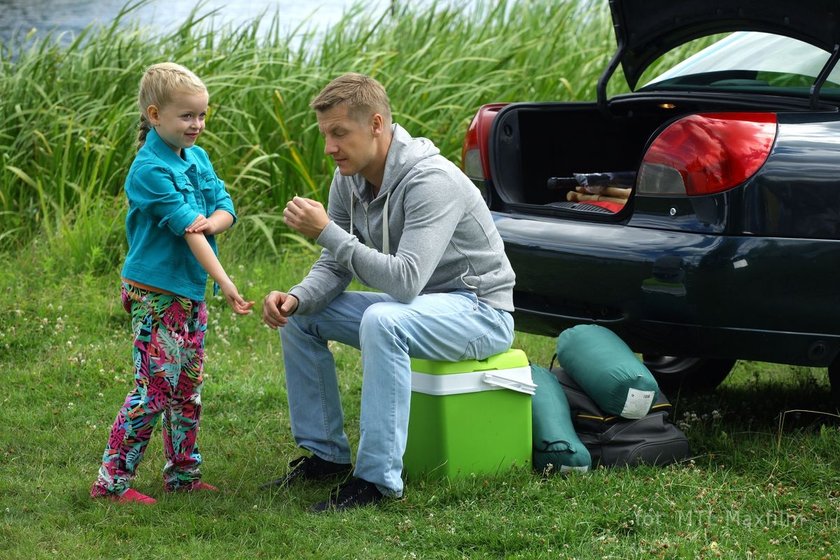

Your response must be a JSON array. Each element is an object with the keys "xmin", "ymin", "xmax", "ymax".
[{"xmin": 309, "ymin": 72, "xmax": 391, "ymax": 125}]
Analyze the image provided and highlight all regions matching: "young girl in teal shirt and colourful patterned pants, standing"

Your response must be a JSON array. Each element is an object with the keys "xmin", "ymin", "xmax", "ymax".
[{"xmin": 91, "ymin": 63, "xmax": 254, "ymax": 504}]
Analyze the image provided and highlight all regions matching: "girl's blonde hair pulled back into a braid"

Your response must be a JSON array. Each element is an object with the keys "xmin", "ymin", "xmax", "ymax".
[{"xmin": 137, "ymin": 62, "xmax": 207, "ymax": 150}]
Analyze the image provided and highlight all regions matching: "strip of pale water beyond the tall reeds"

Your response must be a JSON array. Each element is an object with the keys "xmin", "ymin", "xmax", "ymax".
[{"xmin": 0, "ymin": 0, "xmax": 418, "ymax": 44}]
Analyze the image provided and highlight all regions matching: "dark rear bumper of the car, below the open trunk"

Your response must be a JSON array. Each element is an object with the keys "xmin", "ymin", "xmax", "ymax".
[{"xmin": 494, "ymin": 213, "xmax": 840, "ymax": 366}]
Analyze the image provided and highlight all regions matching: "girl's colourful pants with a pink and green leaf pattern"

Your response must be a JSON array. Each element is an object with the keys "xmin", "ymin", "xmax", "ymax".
[{"xmin": 91, "ymin": 284, "xmax": 207, "ymax": 497}]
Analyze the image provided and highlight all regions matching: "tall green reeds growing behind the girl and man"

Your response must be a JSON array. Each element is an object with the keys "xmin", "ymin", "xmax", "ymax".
[{"xmin": 0, "ymin": 0, "xmax": 615, "ymax": 272}]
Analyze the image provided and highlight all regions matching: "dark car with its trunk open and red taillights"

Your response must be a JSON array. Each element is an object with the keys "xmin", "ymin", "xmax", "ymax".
[{"xmin": 463, "ymin": 0, "xmax": 840, "ymax": 391}]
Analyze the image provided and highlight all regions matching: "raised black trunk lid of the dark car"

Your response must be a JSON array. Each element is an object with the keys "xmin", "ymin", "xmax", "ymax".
[{"xmin": 610, "ymin": 0, "xmax": 840, "ymax": 89}]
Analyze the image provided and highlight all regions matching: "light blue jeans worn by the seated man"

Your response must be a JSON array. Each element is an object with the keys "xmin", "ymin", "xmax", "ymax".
[{"xmin": 280, "ymin": 291, "xmax": 513, "ymax": 497}]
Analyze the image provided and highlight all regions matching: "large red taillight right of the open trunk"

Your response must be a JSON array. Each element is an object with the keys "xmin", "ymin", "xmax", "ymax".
[{"xmin": 638, "ymin": 113, "xmax": 776, "ymax": 196}]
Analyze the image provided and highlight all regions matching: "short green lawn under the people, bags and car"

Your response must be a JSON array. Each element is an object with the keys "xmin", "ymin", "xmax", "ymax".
[{"xmin": 0, "ymin": 247, "xmax": 840, "ymax": 559}]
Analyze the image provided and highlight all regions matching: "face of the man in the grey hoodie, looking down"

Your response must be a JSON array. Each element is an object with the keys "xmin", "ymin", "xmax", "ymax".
[{"xmin": 317, "ymin": 104, "xmax": 377, "ymax": 176}]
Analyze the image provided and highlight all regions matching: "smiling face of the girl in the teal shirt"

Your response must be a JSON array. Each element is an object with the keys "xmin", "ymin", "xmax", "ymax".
[{"xmin": 146, "ymin": 91, "xmax": 209, "ymax": 155}]
